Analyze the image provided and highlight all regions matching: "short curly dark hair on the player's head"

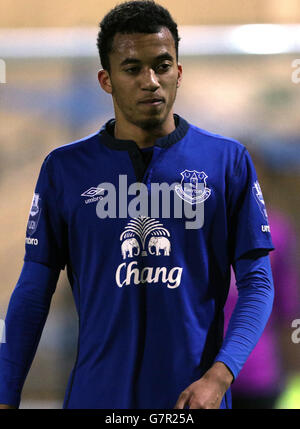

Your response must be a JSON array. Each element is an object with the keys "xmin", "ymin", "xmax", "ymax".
[{"xmin": 97, "ymin": 0, "xmax": 180, "ymax": 71}]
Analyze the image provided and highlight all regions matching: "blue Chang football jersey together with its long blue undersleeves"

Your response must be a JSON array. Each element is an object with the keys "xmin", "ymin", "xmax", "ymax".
[{"xmin": 0, "ymin": 117, "xmax": 273, "ymax": 408}]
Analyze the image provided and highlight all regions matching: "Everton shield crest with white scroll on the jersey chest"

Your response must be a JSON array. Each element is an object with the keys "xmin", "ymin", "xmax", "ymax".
[{"xmin": 175, "ymin": 170, "xmax": 211, "ymax": 204}]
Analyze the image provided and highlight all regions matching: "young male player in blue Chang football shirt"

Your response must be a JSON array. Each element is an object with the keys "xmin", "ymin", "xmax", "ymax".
[{"xmin": 0, "ymin": 1, "xmax": 273, "ymax": 409}]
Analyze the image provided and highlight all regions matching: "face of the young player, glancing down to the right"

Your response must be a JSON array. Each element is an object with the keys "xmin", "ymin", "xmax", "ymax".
[{"xmin": 99, "ymin": 28, "xmax": 182, "ymax": 130}]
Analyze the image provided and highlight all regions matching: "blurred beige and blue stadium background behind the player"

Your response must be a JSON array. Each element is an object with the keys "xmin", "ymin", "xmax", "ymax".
[{"xmin": 0, "ymin": 0, "xmax": 300, "ymax": 408}]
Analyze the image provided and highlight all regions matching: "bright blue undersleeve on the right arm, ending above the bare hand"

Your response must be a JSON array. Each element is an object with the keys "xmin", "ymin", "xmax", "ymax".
[{"xmin": 215, "ymin": 254, "xmax": 274, "ymax": 379}]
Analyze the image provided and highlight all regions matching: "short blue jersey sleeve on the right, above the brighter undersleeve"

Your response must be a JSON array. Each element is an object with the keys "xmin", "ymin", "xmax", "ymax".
[{"xmin": 229, "ymin": 148, "xmax": 274, "ymax": 262}]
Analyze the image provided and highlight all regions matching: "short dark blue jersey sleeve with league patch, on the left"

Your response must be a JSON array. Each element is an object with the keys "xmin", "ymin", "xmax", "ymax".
[{"xmin": 24, "ymin": 154, "xmax": 67, "ymax": 269}]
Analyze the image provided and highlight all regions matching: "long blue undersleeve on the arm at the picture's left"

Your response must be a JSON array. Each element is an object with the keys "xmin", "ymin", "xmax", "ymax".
[{"xmin": 0, "ymin": 262, "xmax": 60, "ymax": 407}]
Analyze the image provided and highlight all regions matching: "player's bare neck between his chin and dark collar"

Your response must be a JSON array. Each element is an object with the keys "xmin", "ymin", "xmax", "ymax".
[{"xmin": 115, "ymin": 113, "xmax": 176, "ymax": 148}]
